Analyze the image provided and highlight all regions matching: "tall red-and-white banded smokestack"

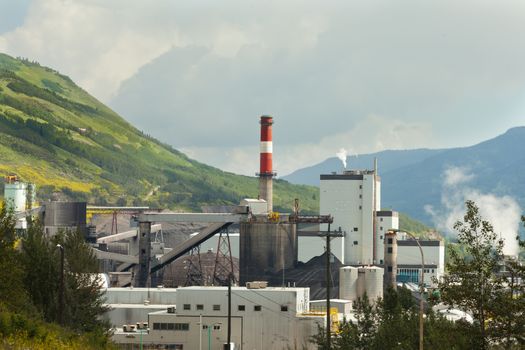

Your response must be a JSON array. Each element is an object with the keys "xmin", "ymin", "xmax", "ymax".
[{"xmin": 258, "ymin": 115, "xmax": 276, "ymax": 213}]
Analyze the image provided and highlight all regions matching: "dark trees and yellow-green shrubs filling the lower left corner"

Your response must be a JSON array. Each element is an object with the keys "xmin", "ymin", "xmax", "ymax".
[{"xmin": 0, "ymin": 205, "xmax": 112, "ymax": 349}]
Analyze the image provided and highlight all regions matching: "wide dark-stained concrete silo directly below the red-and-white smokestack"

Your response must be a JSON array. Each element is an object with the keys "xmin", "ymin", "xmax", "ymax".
[{"xmin": 239, "ymin": 222, "xmax": 297, "ymax": 285}]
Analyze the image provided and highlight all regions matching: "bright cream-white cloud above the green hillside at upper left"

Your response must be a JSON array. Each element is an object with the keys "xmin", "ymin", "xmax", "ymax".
[{"xmin": 0, "ymin": 0, "xmax": 178, "ymax": 101}]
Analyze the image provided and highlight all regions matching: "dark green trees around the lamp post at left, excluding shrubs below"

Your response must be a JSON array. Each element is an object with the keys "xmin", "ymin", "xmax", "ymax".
[{"xmin": 22, "ymin": 223, "xmax": 108, "ymax": 332}]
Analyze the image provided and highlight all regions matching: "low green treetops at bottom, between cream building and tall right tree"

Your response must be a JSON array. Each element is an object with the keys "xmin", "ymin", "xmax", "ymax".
[{"xmin": 312, "ymin": 288, "xmax": 476, "ymax": 350}]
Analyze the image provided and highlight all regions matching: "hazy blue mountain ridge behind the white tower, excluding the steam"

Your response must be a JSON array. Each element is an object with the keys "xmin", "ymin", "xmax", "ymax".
[{"xmin": 284, "ymin": 126, "xmax": 525, "ymax": 224}]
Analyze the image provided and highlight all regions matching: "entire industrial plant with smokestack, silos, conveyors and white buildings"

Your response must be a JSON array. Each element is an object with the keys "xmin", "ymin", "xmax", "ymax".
[{"xmin": 4, "ymin": 116, "xmax": 445, "ymax": 349}]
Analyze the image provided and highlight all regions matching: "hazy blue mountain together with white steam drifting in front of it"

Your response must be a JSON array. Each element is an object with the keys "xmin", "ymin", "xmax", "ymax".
[{"xmin": 284, "ymin": 127, "xmax": 525, "ymax": 243}]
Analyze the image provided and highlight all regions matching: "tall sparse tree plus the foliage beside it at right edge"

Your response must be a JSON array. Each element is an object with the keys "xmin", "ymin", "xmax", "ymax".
[{"xmin": 439, "ymin": 201, "xmax": 525, "ymax": 350}]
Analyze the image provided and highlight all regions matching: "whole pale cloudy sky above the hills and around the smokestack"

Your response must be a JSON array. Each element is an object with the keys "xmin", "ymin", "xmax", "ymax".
[{"xmin": 0, "ymin": 0, "xmax": 525, "ymax": 175}]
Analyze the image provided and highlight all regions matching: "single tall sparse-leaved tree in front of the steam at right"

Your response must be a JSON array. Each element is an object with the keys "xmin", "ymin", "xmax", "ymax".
[{"xmin": 439, "ymin": 201, "xmax": 504, "ymax": 350}]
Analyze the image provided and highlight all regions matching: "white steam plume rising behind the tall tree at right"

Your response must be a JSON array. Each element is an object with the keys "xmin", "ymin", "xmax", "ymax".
[{"xmin": 425, "ymin": 167, "xmax": 521, "ymax": 256}]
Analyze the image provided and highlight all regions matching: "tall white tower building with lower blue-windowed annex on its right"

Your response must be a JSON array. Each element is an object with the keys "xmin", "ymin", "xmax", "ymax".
[{"xmin": 318, "ymin": 163, "xmax": 445, "ymax": 290}]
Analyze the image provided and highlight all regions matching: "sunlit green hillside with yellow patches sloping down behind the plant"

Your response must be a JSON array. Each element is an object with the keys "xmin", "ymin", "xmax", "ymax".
[{"xmin": 0, "ymin": 54, "xmax": 319, "ymax": 212}]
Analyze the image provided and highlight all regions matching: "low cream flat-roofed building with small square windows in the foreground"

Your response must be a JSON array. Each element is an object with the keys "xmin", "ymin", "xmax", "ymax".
[{"xmin": 110, "ymin": 282, "xmax": 325, "ymax": 350}]
